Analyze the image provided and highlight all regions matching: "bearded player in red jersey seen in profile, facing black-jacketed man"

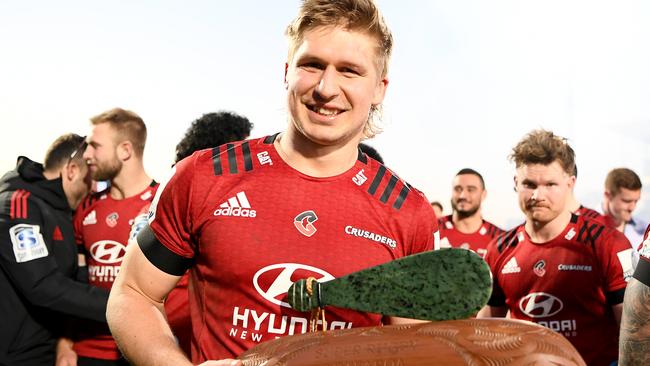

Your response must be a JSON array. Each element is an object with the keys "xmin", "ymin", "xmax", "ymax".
[{"xmin": 61, "ymin": 108, "xmax": 158, "ymax": 366}]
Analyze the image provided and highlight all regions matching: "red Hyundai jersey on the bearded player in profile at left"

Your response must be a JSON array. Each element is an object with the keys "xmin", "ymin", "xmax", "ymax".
[{"xmin": 74, "ymin": 182, "xmax": 158, "ymax": 360}]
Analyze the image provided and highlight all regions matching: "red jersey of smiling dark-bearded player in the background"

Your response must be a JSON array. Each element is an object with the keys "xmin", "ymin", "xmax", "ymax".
[{"xmin": 438, "ymin": 215, "xmax": 504, "ymax": 258}]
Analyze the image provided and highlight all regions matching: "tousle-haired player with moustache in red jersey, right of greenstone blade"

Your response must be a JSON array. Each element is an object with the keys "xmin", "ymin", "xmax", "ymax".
[{"xmin": 479, "ymin": 130, "xmax": 633, "ymax": 365}]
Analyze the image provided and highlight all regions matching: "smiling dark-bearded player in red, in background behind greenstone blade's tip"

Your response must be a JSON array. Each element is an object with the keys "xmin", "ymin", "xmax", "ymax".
[{"xmin": 438, "ymin": 168, "xmax": 503, "ymax": 258}]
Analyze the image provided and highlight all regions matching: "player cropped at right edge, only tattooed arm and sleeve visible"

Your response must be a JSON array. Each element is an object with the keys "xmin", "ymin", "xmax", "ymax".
[{"xmin": 619, "ymin": 225, "xmax": 650, "ymax": 366}]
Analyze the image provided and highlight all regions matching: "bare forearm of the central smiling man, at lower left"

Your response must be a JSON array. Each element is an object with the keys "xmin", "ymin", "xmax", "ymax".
[{"xmin": 106, "ymin": 286, "xmax": 192, "ymax": 365}]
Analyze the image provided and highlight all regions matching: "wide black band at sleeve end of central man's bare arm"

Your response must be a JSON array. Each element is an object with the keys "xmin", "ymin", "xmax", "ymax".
[{"xmin": 137, "ymin": 224, "xmax": 194, "ymax": 276}]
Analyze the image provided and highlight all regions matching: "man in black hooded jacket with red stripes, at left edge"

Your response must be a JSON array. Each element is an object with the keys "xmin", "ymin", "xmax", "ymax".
[{"xmin": 0, "ymin": 134, "xmax": 108, "ymax": 366}]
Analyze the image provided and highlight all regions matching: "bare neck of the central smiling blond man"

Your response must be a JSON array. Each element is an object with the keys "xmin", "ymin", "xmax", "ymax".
[{"xmin": 275, "ymin": 129, "xmax": 359, "ymax": 178}]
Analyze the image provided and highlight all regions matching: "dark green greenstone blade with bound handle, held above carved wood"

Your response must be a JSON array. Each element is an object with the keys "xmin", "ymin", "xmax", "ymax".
[{"xmin": 288, "ymin": 248, "xmax": 492, "ymax": 320}]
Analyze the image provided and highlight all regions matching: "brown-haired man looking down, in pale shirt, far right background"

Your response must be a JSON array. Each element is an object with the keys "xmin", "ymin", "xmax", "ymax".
[{"xmin": 603, "ymin": 168, "xmax": 648, "ymax": 248}]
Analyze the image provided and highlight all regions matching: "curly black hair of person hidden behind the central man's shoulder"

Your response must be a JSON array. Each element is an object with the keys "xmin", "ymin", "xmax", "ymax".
[{"xmin": 175, "ymin": 111, "xmax": 253, "ymax": 163}]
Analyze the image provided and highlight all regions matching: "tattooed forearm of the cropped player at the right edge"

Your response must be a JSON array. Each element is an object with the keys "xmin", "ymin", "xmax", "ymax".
[{"xmin": 619, "ymin": 279, "xmax": 650, "ymax": 365}]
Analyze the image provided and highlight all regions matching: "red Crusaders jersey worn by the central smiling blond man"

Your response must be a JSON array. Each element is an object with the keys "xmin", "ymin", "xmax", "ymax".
[{"xmin": 143, "ymin": 136, "xmax": 437, "ymax": 363}]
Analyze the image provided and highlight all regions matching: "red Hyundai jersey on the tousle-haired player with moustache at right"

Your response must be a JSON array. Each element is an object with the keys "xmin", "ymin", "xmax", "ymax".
[{"xmin": 486, "ymin": 215, "xmax": 634, "ymax": 365}]
